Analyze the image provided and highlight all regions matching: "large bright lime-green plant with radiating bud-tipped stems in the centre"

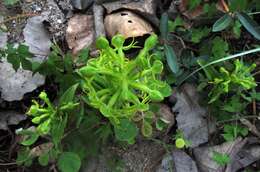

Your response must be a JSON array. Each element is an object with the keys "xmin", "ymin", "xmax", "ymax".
[{"xmin": 78, "ymin": 35, "xmax": 171, "ymax": 142}]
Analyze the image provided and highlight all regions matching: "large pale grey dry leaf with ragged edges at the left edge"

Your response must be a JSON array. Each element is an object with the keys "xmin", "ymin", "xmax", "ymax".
[{"xmin": 0, "ymin": 59, "xmax": 45, "ymax": 101}]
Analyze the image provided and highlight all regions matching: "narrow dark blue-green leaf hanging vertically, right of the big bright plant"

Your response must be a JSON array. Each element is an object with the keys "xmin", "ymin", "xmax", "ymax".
[{"xmin": 164, "ymin": 44, "xmax": 179, "ymax": 74}]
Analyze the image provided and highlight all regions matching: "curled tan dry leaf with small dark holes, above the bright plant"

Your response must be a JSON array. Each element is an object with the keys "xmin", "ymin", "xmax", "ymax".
[{"xmin": 105, "ymin": 10, "xmax": 153, "ymax": 38}]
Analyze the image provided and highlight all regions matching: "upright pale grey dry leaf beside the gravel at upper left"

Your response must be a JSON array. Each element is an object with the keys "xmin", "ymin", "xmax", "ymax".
[{"xmin": 23, "ymin": 16, "xmax": 51, "ymax": 56}]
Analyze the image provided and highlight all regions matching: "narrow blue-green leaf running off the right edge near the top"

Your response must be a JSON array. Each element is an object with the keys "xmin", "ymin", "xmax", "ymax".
[{"xmin": 236, "ymin": 12, "xmax": 260, "ymax": 40}]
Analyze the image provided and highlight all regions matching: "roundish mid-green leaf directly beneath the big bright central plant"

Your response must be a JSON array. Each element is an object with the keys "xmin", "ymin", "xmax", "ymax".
[{"xmin": 114, "ymin": 119, "xmax": 138, "ymax": 144}]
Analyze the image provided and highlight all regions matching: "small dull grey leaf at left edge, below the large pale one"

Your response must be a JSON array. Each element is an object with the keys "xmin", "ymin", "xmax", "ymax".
[{"xmin": 0, "ymin": 111, "xmax": 26, "ymax": 130}]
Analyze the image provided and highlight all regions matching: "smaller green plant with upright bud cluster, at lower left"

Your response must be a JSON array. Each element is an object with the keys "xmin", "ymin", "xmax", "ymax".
[{"xmin": 17, "ymin": 85, "xmax": 80, "ymax": 168}]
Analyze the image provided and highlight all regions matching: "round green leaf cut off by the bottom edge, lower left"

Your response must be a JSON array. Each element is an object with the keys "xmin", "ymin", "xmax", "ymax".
[{"xmin": 58, "ymin": 152, "xmax": 81, "ymax": 172}]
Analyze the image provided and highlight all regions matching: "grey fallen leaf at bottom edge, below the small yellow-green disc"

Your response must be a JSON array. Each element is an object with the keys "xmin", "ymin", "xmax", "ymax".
[{"xmin": 156, "ymin": 149, "xmax": 198, "ymax": 172}]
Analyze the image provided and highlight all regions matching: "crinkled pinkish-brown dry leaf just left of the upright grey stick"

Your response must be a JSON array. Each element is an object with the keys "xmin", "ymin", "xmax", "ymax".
[{"xmin": 66, "ymin": 15, "xmax": 94, "ymax": 54}]
